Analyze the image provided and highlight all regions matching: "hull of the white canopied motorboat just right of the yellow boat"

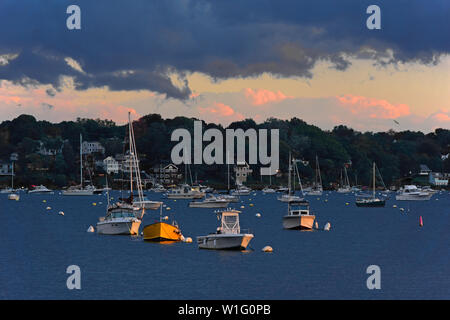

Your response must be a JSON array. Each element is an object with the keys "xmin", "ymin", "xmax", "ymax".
[{"xmin": 197, "ymin": 233, "xmax": 253, "ymax": 250}]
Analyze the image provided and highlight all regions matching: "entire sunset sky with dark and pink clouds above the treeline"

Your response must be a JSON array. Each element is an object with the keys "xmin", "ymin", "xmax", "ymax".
[{"xmin": 0, "ymin": 0, "xmax": 450, "ymax": 132}]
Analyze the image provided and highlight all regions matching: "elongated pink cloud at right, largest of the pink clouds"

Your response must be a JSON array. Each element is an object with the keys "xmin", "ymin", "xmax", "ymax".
[{"xmin": 336, "ymin": 94, "xmax": 411, "ymax": 119}]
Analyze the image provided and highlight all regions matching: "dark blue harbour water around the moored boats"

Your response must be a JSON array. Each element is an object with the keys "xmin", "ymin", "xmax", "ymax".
[{"xmin": 0, "ymin": 192, "xmax": 450, "ymax": 299}]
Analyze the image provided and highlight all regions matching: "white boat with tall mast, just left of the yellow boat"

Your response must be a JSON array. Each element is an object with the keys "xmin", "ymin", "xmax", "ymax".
[{"xmin": 97, "ymin": 113, "xmax": 145, "ymax": 235}]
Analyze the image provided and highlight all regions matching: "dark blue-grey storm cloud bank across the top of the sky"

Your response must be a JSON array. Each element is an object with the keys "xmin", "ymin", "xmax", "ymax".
[{"xmin": 0, "ymin": 0, "xmax": 450, "ymax": 99}]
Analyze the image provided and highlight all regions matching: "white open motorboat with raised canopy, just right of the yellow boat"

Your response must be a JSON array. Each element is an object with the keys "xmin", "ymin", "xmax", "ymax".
[{"xmin": 197, "ymin": 209, "xmax": 254, "ymax": 250}]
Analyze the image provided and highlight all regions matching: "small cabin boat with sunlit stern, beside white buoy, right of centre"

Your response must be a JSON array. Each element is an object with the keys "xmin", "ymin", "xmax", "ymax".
[{"xmin": 283, "ymin": 200, "xmax": 316, "ymax": 230}]
